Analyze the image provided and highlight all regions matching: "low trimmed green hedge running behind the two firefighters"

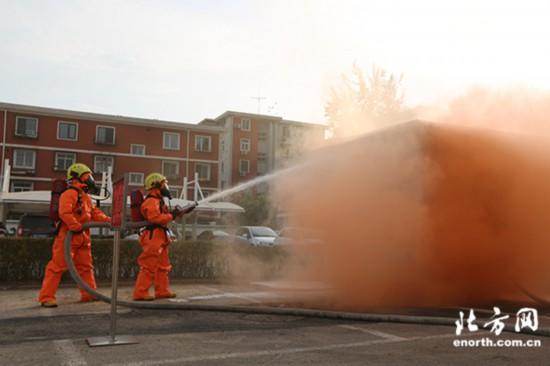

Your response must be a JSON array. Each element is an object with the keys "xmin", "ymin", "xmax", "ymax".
[{"xmin": 0, "ymin": 238, "xmax": 286, "ymax": 283}]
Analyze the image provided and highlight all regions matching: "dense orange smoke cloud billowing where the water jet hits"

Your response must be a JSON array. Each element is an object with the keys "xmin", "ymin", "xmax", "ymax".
[{"xmin": 281, "ymin": 88, "xmax": 550, "ymax": 310}]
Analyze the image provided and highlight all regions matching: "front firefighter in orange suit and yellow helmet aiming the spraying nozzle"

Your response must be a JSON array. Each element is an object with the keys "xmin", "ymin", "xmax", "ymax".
[{"xmin": 133, "ymin": 173, "xmax": 196, "ymax": 301}]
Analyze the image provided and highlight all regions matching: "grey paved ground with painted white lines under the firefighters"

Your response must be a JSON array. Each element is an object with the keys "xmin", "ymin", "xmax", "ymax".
[{"xmin": 0, "ymin": 284, "xmax": 550, "ymax": 366}]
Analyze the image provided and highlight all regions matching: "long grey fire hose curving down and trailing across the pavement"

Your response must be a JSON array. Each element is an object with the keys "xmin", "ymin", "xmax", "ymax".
[{"xmin": 64, "ymin": 222, "xmax": 550, "ymax": 337}]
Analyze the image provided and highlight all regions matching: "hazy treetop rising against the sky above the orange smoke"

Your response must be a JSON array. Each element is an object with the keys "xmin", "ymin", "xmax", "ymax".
[{"xmin": 325, "ymin": 64, "xmax": 409, "ymax": 137}]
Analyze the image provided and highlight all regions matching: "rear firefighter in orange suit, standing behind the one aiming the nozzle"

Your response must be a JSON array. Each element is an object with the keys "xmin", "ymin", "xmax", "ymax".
[{"xmin": 38, "ymin": 163, "xmax": 111, "ymax": 307}]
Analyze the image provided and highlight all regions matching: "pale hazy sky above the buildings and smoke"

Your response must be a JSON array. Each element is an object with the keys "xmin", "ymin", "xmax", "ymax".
[{"xmin": 0, "ymin": 0, "xmax": 550, "ymax": 123}]
